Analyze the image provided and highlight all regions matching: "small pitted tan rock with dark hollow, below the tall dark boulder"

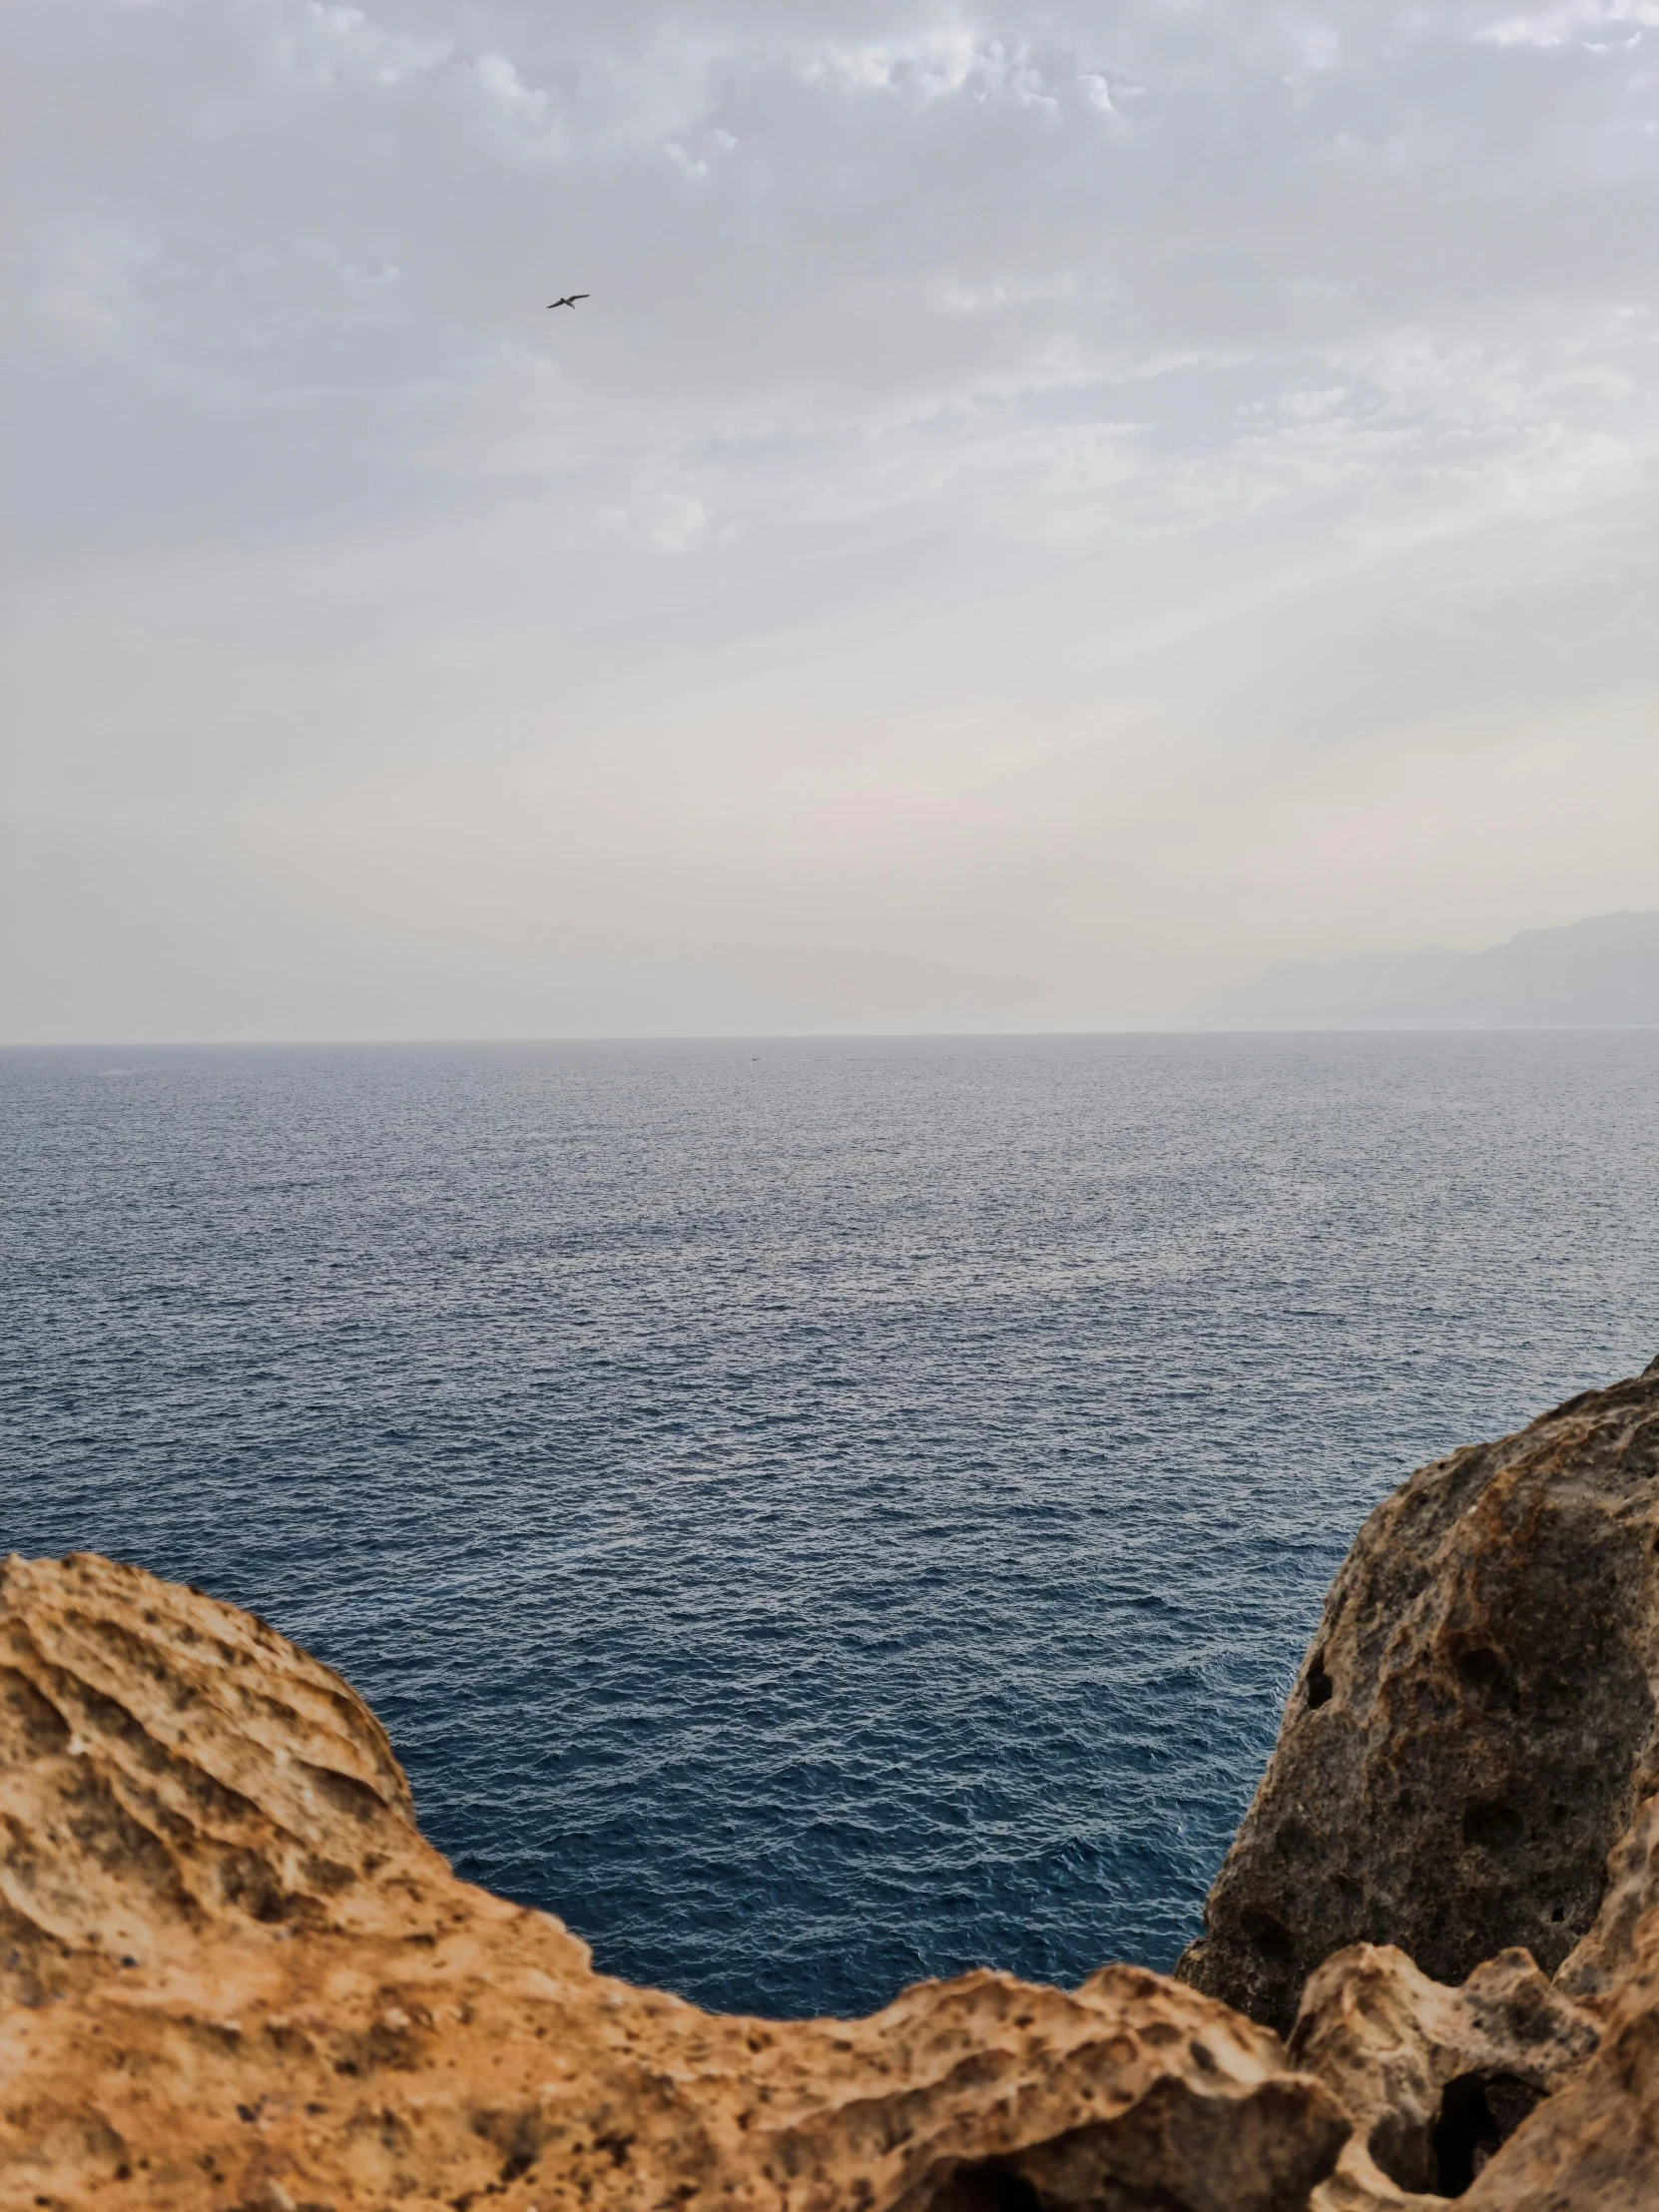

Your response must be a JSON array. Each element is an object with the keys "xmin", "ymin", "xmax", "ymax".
[{"xmin": 1290, "ymin": 1944, "xmax": 1599, "ymax": 2212}]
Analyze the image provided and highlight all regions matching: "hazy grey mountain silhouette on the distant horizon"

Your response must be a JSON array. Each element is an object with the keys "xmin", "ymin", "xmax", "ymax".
[{"xmin": 1210, "ymin": 913, "xmax": 1659, "ymax": 1028}]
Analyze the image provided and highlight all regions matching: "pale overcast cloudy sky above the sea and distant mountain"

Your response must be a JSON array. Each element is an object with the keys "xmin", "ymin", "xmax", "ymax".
[{"xmin": 0, "ymin": 0, "xmax": 1659, "ymax": 1042}]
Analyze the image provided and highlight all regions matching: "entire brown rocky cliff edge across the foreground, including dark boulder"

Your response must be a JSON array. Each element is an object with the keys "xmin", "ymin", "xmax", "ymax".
[{"xmin": 0, "ymin": 1367, "xmax": 1659, "ymax": 2212}]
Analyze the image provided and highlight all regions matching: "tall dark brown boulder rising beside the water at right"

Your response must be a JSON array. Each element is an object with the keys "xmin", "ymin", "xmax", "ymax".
[{"xmin": 1177, "ymin": 1363, "xmax": 1659, "ymax": 2033}]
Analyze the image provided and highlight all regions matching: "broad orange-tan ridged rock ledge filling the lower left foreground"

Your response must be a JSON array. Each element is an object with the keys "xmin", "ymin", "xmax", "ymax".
[{"xmin": 0, "ymin": 1555, "xmax": 1350, "ymax": 2212}]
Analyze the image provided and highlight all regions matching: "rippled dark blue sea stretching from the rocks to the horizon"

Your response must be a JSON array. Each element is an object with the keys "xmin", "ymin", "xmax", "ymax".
[{"xmin": 0, "ymin": 1033, "xmax": 1659, "ymax": 2015}]
